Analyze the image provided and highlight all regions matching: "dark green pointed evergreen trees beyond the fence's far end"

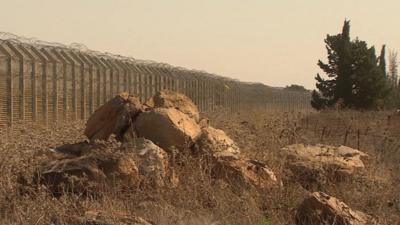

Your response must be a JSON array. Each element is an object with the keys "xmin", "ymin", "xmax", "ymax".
[{"xmin": 311, "ymin": 20, "xmax": 388, "ymax": 109}]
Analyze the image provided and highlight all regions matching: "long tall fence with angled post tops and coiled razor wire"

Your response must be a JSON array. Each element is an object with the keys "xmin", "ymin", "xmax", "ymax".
[{"xmin": 0, "ymin": 32, "xmax": 310, "ymax": 125}]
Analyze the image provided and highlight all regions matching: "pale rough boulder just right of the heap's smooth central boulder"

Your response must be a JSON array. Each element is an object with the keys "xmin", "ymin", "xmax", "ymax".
[{"xmin": 196, "ymin": 126, "xmax": 240, "ymax": 159}]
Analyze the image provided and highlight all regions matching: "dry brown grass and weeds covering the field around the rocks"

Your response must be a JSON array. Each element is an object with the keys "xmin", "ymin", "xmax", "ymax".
[{"xmin": 0, "ymin": 111, "xmax": 400, "ymax": 225}]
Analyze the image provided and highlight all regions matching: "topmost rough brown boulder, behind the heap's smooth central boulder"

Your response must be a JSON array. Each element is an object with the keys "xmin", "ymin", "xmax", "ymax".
[{"xmin": 147, "ymin": 90, "xmax": 200, "ymax": 122}]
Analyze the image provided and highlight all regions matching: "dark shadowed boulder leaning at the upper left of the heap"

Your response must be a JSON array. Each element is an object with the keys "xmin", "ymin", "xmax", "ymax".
[{"xmin": 84, "ymin": 92, "xmax": 143, "ymax": 141}]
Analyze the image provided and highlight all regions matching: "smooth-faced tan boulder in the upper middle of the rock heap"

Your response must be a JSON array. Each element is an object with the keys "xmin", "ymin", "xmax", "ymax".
[{"xmin": 135, "ymin": 108, "xmax": 201, "ymax": 151}]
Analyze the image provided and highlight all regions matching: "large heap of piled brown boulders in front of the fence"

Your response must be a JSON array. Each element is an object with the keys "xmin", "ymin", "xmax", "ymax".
[{"xmin": 34, "ymin": 91, "xmax": 277, "ymax": 195}]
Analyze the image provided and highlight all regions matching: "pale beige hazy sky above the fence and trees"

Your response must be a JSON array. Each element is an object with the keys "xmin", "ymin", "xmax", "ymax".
[{"xmin": 0, "ymin": 0, "xmax": 400, "ymax": 88}]
